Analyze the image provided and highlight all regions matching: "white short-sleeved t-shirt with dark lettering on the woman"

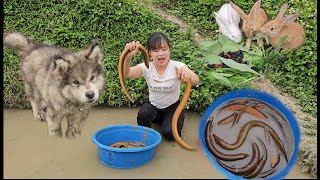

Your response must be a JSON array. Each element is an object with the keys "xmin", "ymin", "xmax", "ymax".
[{"xmin": 139, "ymin": 60, "xmax": 185, "ymax": 109}]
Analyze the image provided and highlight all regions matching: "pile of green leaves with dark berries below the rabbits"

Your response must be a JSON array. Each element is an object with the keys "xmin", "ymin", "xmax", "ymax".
[{"xmin": 198, "ymin": 34, "xmax": 264, "ymax": 89}]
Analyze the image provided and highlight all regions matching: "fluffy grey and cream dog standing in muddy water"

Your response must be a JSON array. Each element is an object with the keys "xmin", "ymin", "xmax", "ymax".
[{"xmin": 3, "ymin": 32, "xmax": 105, "ymax": 137}]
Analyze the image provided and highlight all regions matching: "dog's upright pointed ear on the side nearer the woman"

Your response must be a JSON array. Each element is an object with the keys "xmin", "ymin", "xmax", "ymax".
[{"xmin": 84, "ymin": 40, "xmax": 103, "ymax": 64}]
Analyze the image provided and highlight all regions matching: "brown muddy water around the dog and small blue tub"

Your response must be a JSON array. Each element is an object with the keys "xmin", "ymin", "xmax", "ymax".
[{"xmin": 3, "ymin": 107, "xmax": 312, "ymax": 179}]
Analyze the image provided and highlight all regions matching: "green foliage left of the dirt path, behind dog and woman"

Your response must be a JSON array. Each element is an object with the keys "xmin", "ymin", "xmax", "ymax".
[{"xmin": 3, "ymin": 0, "xmax": 227, "ymax": 112}]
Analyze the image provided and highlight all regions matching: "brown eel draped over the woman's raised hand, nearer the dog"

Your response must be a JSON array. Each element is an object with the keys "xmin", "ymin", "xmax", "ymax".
[{"xmin": 118, "ymin": 46, "xmax": 150, "ymax": 103}]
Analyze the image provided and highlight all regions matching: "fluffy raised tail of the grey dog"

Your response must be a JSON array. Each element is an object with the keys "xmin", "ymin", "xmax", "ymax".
[{"xmin": 3, "ymin": 32, "xmax": 31, "ymax": 55}]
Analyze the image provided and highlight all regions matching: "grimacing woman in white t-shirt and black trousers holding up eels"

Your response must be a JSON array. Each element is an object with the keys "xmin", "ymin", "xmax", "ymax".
[{"xmin": 123, "ymin": 32, "xmax": 199, "ymax": 140}]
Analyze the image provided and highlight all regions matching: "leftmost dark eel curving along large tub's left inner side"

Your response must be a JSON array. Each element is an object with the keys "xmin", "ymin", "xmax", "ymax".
[{"xmin": 205, "ymin": 119, "xmax": 249, "ymax": 161}]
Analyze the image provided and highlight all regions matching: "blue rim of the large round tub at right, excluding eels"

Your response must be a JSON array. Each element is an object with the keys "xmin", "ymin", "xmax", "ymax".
[{"xmin": 199, "ymin": 89, "xmax": 300, "ymax": 180}]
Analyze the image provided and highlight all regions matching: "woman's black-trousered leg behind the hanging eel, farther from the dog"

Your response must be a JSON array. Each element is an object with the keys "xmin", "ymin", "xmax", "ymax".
[{"xmin": 161, "ymin": 101, "xmax": 185, "ymax": 141}]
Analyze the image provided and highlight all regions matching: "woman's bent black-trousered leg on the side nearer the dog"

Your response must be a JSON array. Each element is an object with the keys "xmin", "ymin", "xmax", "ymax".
[{"xmin": 137, "ymin": 102, "xmax": 159, "ymax": 128}]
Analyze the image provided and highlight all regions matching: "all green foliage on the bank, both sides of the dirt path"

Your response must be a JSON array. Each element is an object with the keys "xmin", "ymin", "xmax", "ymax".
[{"xmin": 3, "ymin": 0, "xmax": 317, "ymax": 116}]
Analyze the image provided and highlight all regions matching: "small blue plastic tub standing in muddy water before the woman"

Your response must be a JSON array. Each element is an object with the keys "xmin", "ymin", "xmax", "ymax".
[{"xmin": 92, "ymin": 124, "xmax": 161, "ymax": 168}]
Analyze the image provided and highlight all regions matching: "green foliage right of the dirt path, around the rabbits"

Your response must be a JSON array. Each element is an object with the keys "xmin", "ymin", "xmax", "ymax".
[{"xmin": 152, "ymin": 0, "xmax": 317, "ymax": 117}]
